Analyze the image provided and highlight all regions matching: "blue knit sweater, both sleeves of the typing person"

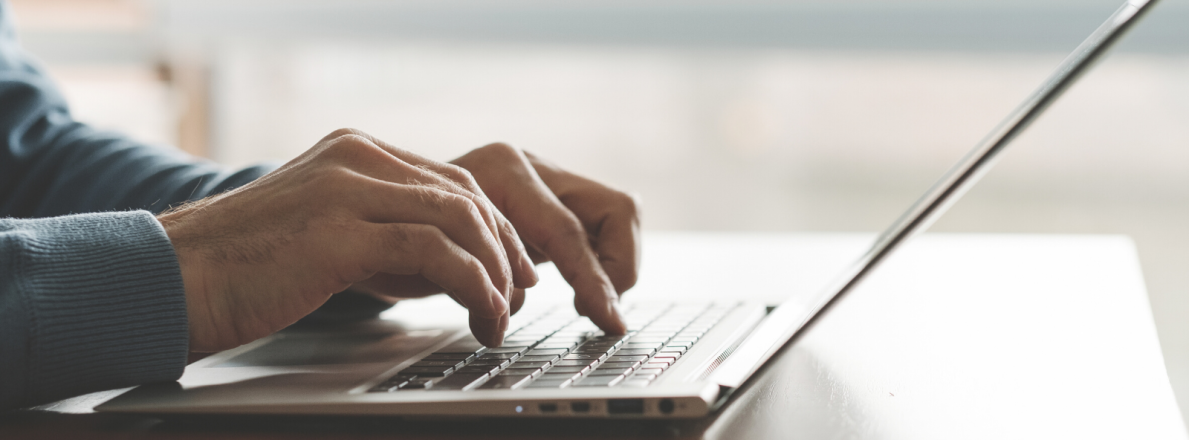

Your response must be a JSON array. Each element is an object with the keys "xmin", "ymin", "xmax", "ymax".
[{"xmin": 0, "ymin": 1, "xmax": 268, "ymax": 409}]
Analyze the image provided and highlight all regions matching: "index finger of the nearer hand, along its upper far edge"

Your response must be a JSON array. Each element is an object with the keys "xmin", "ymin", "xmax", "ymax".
[{"xmin": 335, "ymin": 131, "xmax": 539, "ymax": 288}]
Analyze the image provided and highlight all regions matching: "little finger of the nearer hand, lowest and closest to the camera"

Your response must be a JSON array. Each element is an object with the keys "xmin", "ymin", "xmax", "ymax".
[{"xmin": 358, "ymin": 224, "xmax": 509, "ymax": 319}]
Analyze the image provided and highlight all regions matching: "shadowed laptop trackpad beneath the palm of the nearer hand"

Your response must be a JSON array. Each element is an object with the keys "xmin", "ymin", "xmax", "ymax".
[{"xmin": 214, "ymin": 331, "xmax": 442, "ymax": 367}]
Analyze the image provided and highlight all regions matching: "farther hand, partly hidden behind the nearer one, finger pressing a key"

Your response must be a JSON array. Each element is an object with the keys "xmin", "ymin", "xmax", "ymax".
[{"xmin": 452, "ymin": 144, "xmax": 640, "ymax": 334}]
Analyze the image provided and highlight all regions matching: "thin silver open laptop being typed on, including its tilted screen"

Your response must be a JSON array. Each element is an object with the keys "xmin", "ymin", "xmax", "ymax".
[{"xmin": 96, "ymin": 0, "xmax": 1156, "ymax": 419}]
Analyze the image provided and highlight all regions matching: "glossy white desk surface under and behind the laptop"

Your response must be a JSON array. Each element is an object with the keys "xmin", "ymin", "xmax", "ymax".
[{"xmin": 0, "ymin": 233, "xmax": 1187, "ymax": 439}]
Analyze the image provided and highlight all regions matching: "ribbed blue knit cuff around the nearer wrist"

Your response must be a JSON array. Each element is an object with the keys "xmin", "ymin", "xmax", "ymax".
[{"xmin": 20, "ymin": 210, "xmax": 189, "ymax": 402}]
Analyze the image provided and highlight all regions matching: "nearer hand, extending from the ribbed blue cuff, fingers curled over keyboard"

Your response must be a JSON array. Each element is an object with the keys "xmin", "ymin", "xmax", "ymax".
[{"xmin": 158, "ymin": 130, "xmax": 537, "ymax": 352}]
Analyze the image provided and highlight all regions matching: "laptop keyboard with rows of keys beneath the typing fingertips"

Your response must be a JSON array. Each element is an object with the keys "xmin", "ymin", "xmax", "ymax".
[{"xmin": 369, "ymin": 303, "xmax": 736, "ymax": 392}]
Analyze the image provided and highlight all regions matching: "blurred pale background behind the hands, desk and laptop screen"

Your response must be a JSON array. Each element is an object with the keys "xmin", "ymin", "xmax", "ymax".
[{"xmin": 12, "ymin": 0, "xmax": 1189, "ymax": 420}]
